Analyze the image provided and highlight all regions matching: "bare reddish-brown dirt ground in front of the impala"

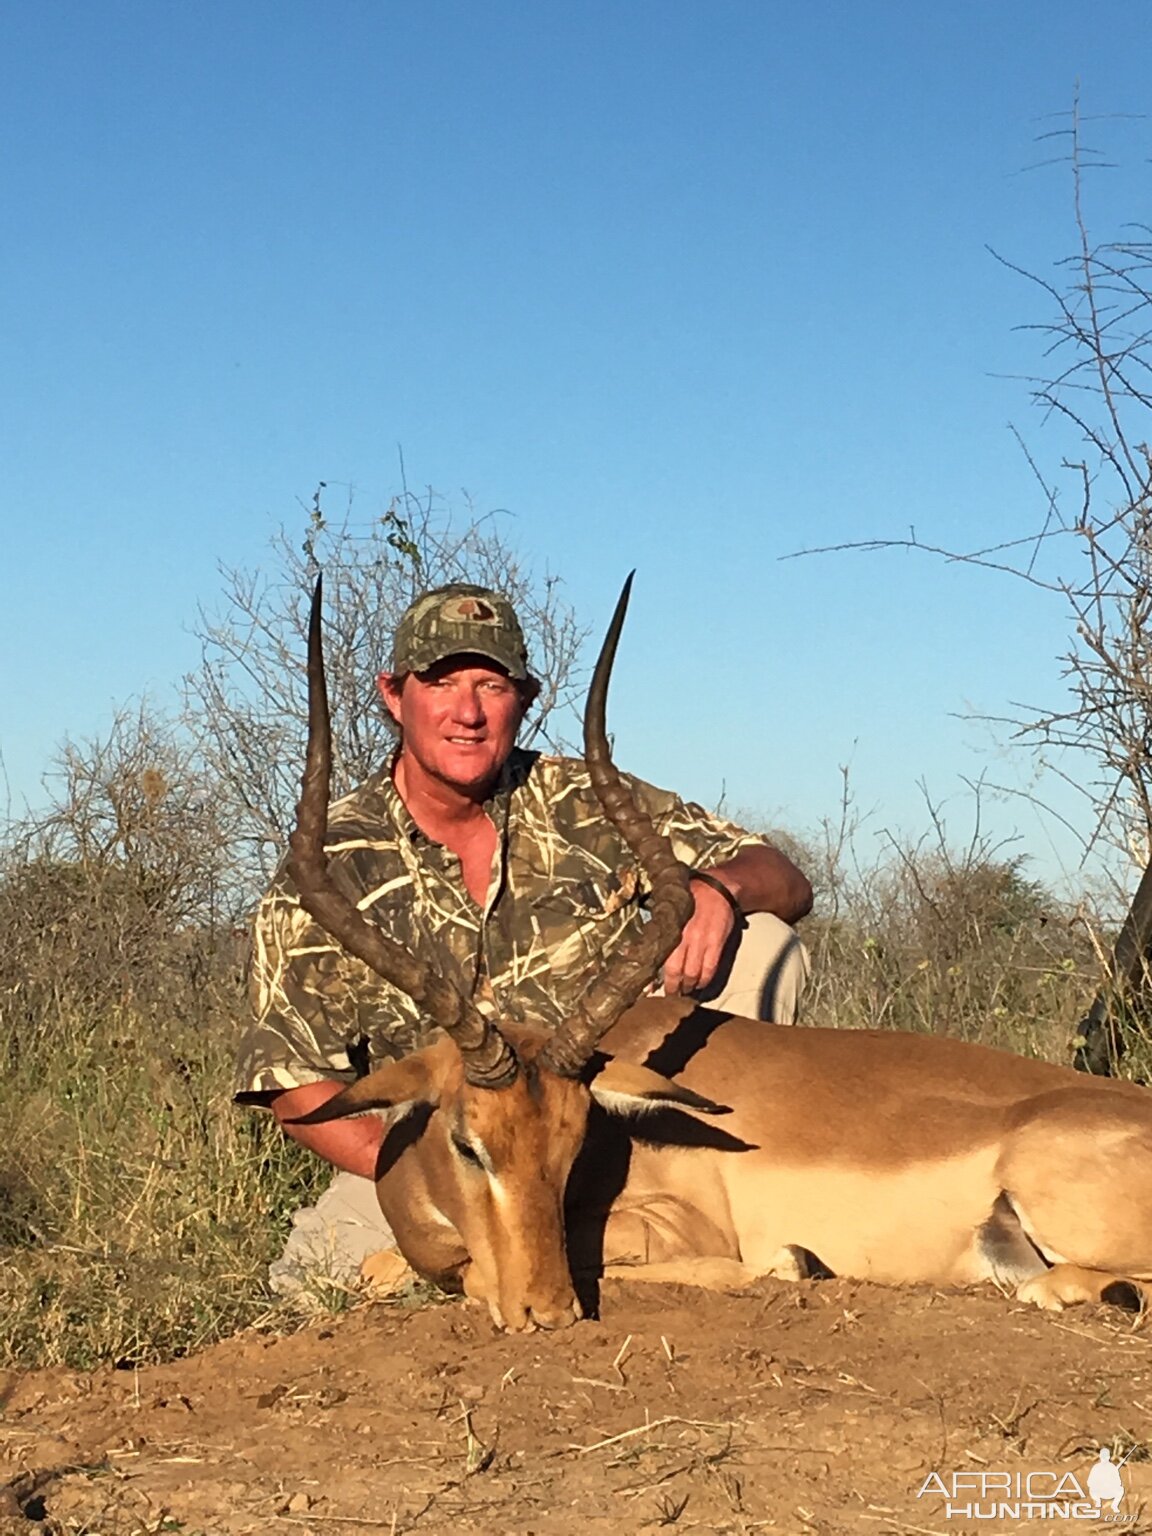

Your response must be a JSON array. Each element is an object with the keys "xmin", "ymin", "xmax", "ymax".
[{"xmin": 0, "ymin": 1281, "xmax": 1152, "ymax": 1536}]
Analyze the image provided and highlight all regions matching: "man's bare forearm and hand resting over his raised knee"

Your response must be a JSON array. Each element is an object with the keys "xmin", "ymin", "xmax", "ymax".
[{"xmin": 664, "ymin": 843, "xmax": 813, "ymax": 994}]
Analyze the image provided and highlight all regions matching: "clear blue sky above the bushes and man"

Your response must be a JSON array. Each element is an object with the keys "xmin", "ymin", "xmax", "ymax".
[{"xmin": 0, "ymin": 0, "xmax": 1152, "ymax": 872}]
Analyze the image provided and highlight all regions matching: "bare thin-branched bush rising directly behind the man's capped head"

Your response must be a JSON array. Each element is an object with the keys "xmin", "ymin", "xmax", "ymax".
[{"xmin": 186, "ymin": 485, "xmax": 587, "ymax": 879}]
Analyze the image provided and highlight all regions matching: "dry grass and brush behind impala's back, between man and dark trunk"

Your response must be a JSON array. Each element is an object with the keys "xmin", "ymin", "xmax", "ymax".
[{"xmin": 773, "ymin": 823, "xmax": 1152, "ymax": 1078}]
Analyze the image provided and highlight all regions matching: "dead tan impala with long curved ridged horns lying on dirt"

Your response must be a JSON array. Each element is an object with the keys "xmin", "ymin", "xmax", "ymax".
[{"xmin": 290, "ymin": 578, "xmax": 1152, "ymax": 1330}]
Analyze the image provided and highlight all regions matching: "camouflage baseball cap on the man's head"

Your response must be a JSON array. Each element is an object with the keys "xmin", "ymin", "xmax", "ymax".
[{"xmin": 392, "ymin": 582, "xmax": 528, "ymax": 680}]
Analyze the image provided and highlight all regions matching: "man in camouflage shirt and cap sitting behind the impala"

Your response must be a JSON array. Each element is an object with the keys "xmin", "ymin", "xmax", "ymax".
[{"xmin": 237, "ymin": 584, "xmax": 813, "ymax": 1293}]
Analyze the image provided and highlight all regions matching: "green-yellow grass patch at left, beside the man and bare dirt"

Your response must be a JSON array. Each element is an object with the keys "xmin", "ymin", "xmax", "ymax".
[{"xmin": 0, "ymin": 958, "xmax": 328, "ymax": 1367}]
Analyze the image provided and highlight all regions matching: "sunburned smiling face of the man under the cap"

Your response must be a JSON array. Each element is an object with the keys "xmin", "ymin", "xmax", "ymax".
[{"xmin": 378, "ymin": 656, "xmax": 524, "ymax": 794}]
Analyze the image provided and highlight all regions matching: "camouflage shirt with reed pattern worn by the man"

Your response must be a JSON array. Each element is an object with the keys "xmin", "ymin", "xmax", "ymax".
[{"xmin": 237, "ymin": 748, "xmax": 763, "ymax": 1103}]
